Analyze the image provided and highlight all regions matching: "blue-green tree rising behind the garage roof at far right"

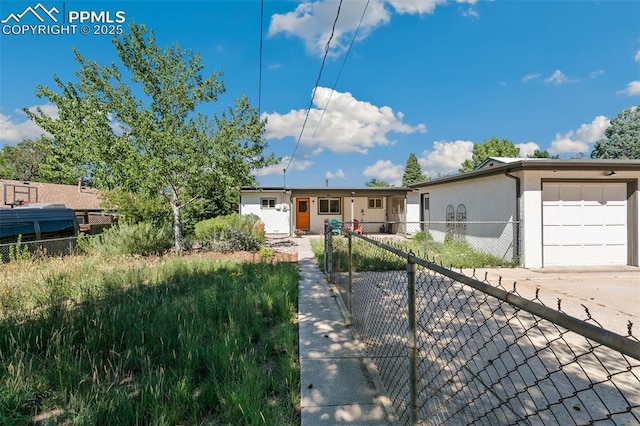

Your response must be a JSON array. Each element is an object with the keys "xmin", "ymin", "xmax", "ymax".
[{"xmin": 591, "ymin": 105, "xmax": 640, "ymax": 159}]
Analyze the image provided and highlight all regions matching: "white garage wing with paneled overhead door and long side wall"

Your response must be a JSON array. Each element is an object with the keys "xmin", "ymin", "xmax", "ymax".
[{"xmin": 407, "ymin": 158, "xmax": 640, "ymax": 268}]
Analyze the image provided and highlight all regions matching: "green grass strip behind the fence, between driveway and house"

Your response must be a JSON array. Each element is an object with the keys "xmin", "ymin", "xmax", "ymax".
[{"xmin": 311, "ymin": 231, "xmax": 517, "ymax": 271}]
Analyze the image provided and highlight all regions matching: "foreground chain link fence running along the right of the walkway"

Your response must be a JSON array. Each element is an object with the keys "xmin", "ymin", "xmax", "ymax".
[{"xmin": 324, "ymin": 221, "xmax": 640, "ymax": 425}]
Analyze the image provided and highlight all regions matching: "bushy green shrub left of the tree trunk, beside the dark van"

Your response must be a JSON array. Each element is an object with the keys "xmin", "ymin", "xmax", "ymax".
[{"xmin": 78, "ymin": 222, "xmax": 173, "ymax": 256}]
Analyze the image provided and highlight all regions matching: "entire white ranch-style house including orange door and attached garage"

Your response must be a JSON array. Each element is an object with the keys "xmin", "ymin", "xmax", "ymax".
[{"xmin": 240, "ymin": 158, "xmax": 640, "ymax": 268}]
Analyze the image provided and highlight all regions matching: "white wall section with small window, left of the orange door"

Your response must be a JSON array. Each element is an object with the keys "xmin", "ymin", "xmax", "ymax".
[{"xmin": 240, "ymin": 191, "xmax": 291, "ymax": 235}]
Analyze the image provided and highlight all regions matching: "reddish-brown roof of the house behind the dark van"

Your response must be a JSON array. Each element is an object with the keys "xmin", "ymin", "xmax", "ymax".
[{"xmin": 0, "ymin": 179, "xmax": 103, "ymax": 210}]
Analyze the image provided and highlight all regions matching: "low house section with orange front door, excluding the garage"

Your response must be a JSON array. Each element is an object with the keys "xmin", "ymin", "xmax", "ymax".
[{"xmin": 240, "ymin": 187, "xmax": 407, "ymax": 235}]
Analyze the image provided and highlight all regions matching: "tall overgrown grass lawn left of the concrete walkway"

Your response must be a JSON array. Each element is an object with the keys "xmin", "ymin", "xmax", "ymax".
[{"xmin": 0, "ymin": 256, "xmax": 300, "ymax": 425}]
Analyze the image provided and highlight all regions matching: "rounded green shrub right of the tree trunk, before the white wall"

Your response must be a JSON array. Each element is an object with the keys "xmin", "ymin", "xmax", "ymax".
[{"xmin": 195, "ymin": 213, "xmax": 265, "ymax": 252}]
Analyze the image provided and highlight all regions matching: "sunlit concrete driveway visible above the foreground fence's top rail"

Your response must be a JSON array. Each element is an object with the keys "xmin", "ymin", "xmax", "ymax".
[{"xmin": 463, "ymin": 266, "xmax": 640, "ymax": 338}]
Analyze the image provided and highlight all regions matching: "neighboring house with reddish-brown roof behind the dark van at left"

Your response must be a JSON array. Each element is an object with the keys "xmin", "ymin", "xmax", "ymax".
[{"xmin": 0, "ymin": 179, "xmax": 114, "ymax": 232}]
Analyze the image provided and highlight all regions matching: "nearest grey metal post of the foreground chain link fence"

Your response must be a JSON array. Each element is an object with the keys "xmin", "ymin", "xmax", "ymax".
[{"xmin": 407, "ymin": 252, "xmax": 419, "ymax": 425}]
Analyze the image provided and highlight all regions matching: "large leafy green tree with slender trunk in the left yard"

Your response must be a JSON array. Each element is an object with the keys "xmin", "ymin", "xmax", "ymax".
[{"xmin": 25, "ymin": 24, "xmax": 276, "ymax": 253}]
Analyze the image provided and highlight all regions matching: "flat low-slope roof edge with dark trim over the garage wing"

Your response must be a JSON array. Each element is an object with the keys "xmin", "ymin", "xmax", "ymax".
[{"xmin": 409, "ymin": 158, "xmax": 640, "ymax": 189}]
